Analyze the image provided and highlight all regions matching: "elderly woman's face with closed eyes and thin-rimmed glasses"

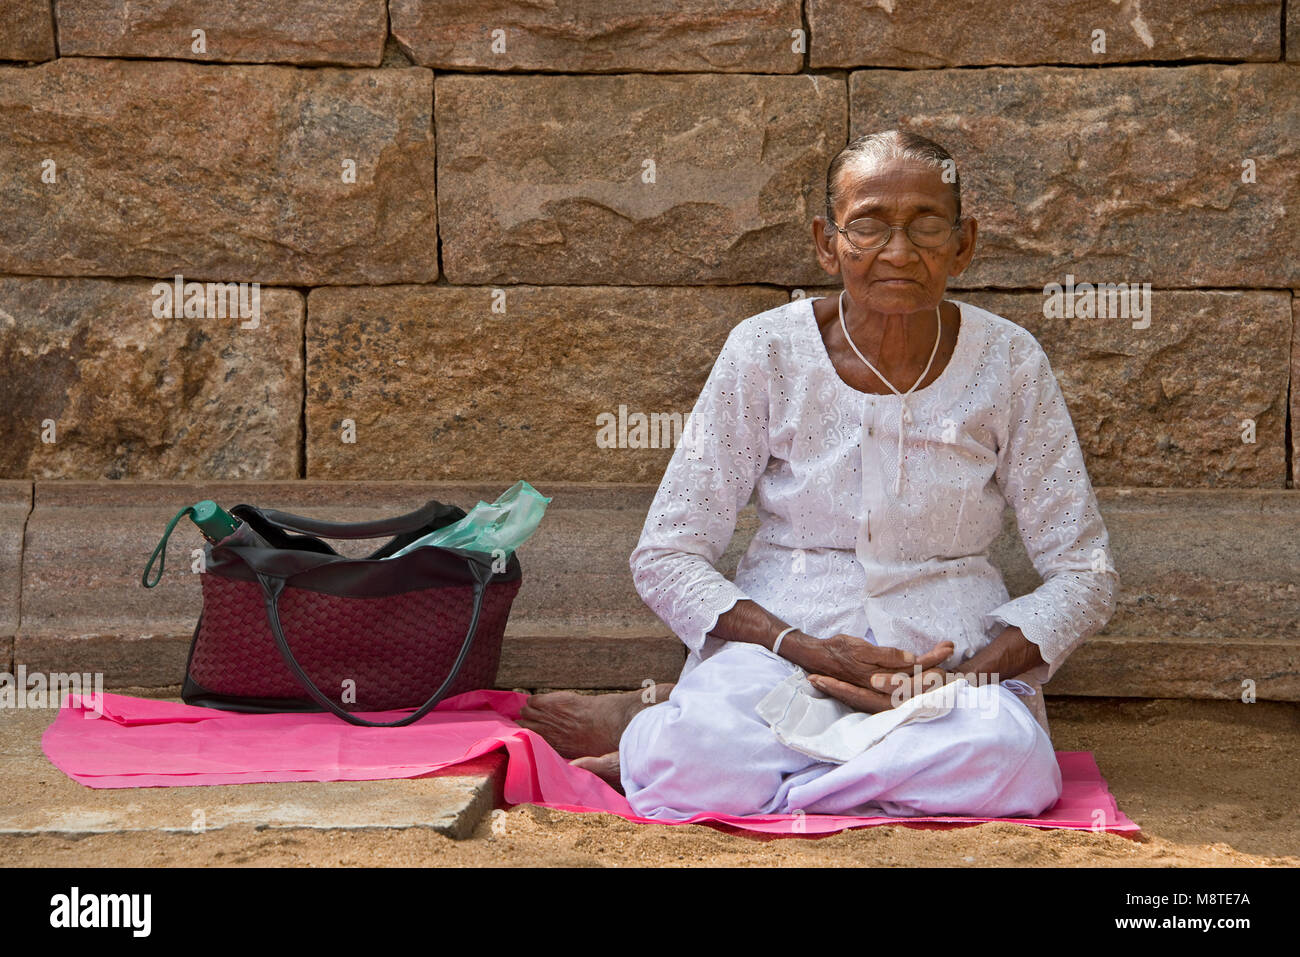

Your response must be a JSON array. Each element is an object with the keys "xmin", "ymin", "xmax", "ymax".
[{"xmin": 813, "ymin": 160, "xmax": 975, "ymax": 315}]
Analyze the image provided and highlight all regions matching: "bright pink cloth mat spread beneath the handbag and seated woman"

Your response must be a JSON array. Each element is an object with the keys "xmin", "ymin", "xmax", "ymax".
[{"xmin": 40, "ymin": 690, "xmax": 1140, "ymax": 835}]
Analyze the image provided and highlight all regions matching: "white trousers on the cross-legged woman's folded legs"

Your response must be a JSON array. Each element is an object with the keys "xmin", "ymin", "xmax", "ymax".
[{"xmin": 619, "ymin": 641, "xmax": 1061, "ymax": 820}]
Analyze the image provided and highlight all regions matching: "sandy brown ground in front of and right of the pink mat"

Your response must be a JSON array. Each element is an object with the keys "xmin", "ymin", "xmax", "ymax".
[{"xmin": 0, "ymin": 698, "xmax": 1300, "ymax": 867}]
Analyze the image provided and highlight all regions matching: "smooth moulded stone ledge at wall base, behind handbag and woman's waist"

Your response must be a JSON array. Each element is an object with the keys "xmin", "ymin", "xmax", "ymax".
[{"xmin": 0, "ymin": 480, "xmax": 1300, "ymax": 701}]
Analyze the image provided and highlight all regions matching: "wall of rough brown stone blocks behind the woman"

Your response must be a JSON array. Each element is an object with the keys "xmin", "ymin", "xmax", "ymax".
[{"xmin": 0, "ymin": 0, "xmax": 1300, "ymax": 489}]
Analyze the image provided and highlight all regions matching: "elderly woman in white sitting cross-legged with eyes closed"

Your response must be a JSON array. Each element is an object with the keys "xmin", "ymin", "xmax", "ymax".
[{"xmin": 520, "ymin": 130, "xmax": 1118, "ymax": 820}]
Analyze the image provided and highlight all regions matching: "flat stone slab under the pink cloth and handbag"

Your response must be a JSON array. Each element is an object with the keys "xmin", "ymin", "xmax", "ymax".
[{"xmin": 0, "ymin": 709, "xmax": 506, "ymax": 840}]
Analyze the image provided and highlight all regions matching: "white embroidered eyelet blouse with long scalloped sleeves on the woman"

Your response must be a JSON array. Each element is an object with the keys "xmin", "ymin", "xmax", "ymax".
[{"xmin": 629, "ymin": 299, "xmax": 1119, "ymax": 681}]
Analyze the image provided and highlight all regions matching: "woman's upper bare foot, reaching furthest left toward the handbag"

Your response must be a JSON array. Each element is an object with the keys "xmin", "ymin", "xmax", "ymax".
[{"xmin": 517, "ymin": 684, "xmax": 672, "ymax": 758}]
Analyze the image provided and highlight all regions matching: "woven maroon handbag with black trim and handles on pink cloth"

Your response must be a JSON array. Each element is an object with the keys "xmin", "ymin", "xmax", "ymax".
[{"xmin": 181, "ymin": 501, "xmax": 523, "ymax": 727}]
